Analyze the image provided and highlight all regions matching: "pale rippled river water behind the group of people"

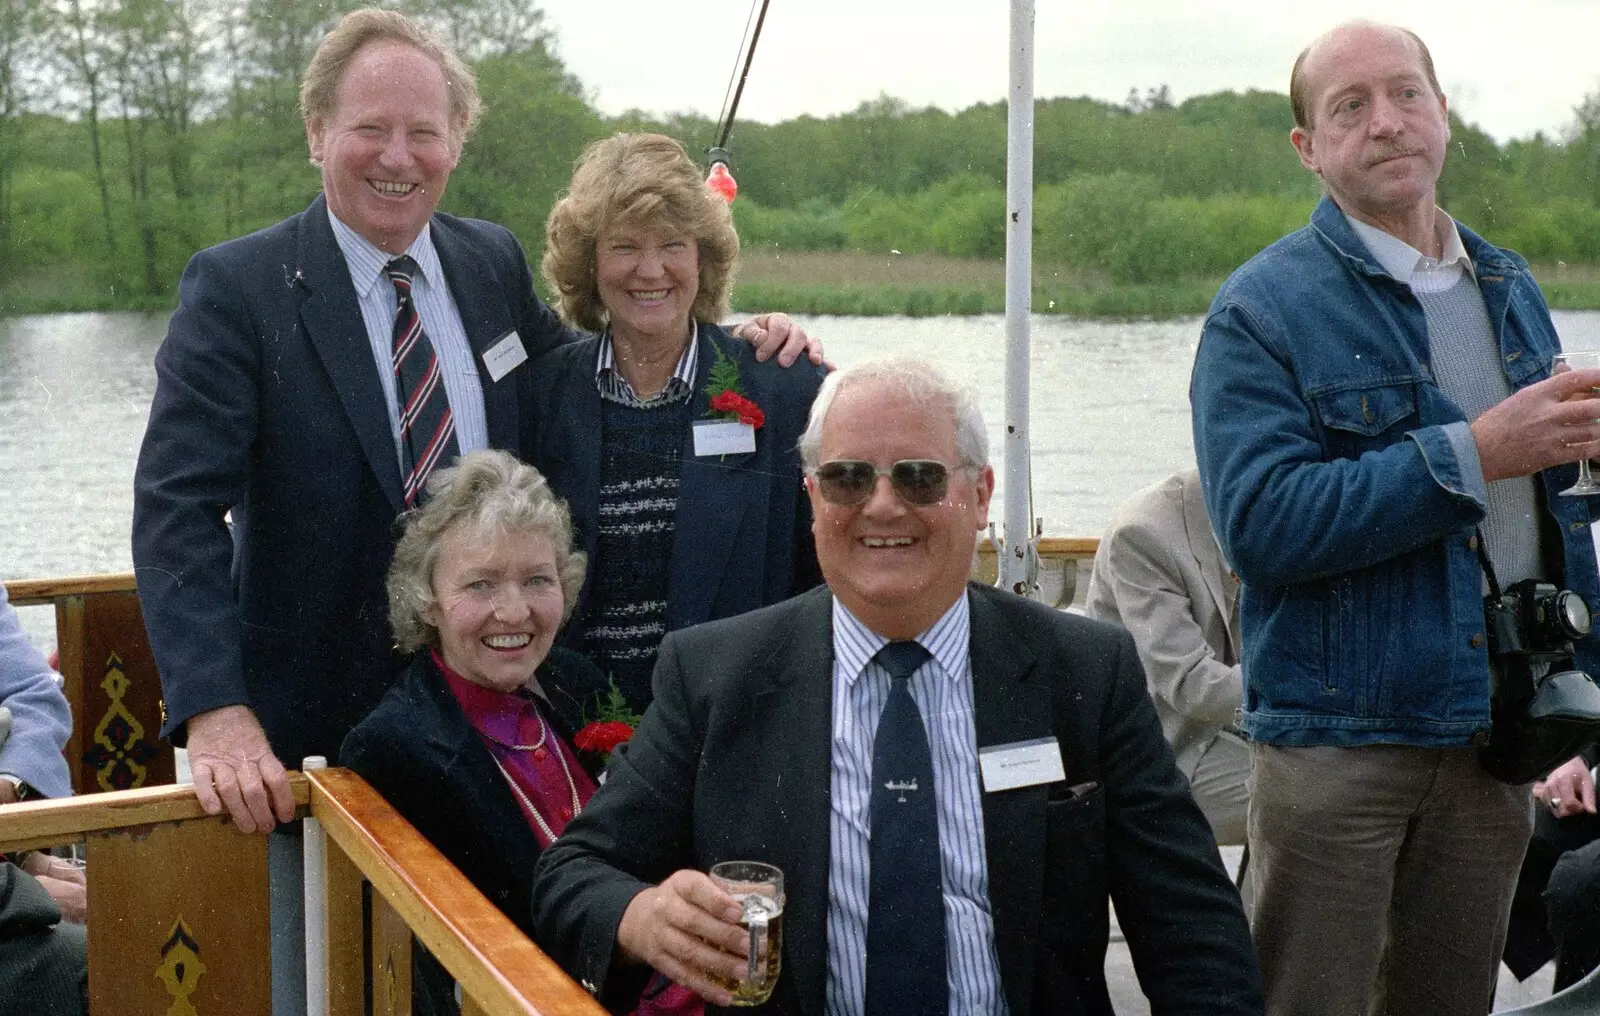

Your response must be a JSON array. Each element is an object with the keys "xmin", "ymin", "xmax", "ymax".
[{"xmin": 9, "ymin": 312, "xmax": 1600, "ymax": 627}]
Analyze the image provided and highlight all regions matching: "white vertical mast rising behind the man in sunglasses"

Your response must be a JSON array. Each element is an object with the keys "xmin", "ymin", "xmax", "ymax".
[{"xmin": 1000, "ymin": 0, "xmax": 1038, "ymax": 595}]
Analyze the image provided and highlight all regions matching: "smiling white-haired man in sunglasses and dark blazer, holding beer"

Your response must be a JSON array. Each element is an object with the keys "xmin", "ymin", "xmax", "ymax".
[{"xmin": 534, "ymin": 360, "xmax": 1261, "ymax": 1016}]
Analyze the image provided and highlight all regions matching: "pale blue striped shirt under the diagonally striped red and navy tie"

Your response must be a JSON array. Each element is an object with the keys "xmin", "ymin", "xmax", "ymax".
[{"xmin": 328, "ymin": 211, "xmax": 490, "ymax": 475}]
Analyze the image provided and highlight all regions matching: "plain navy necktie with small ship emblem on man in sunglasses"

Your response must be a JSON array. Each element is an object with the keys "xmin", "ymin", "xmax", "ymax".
[{"xmin": 866, "ymin": 642, "xmax": 950, "ymax": 1016}]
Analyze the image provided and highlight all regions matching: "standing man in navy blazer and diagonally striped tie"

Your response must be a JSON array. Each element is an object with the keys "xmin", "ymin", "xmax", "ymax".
[{"xmin": 133, "ymin": 10, "xmax": 819, "ymax": 832}]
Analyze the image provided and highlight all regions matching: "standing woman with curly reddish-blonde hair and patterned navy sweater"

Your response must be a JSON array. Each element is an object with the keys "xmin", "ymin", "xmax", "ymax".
[{"xmin": 530, "ymin": 134, "xmax": 824, "ymax": 712}]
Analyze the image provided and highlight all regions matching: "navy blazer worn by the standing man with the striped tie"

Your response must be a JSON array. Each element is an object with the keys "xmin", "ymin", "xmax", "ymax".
[{"xmin": 133, "ymin": 197, "xmax": 568, "ymax": 766}]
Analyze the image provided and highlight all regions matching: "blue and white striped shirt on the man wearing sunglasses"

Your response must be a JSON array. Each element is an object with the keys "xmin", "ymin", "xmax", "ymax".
[{"xmin": 827, "ymin": 594, "xmax": 1006, "ymax": 1016}]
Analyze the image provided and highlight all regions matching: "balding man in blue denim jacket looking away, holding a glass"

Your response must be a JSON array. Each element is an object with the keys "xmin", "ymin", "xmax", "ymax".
[{"xmin": 1190, "ymin": 22, "xmax": 1600, "ymax": 1016}]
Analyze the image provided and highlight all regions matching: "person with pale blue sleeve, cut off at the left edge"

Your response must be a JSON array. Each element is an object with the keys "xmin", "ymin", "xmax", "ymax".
[{"xmin": 0, "ymin": 584, "xmax": 88, "ymax": 1016}]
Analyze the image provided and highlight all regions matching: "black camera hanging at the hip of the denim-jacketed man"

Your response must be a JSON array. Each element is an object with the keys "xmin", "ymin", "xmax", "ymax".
[{"xmin": 1478, "ymin": 579, "xmax": 1600, "ymax": 784}]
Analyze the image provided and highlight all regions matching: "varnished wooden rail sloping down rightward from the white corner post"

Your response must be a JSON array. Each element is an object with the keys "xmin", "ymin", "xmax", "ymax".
[{"xmin": 306, "ymin": 770, "xmax": 605, "ymax": 1016}]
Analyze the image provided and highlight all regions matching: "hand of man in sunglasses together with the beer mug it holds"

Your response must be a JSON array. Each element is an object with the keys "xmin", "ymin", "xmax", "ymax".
[{"xmin": 616, "ymin": 861, "xmax": 784, "ymax": 1006}]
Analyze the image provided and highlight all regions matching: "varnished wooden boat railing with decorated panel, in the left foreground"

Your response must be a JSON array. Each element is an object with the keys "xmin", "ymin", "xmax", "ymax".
[{"xmin": 0, "ymin": 770, "xmax": 605, "ymax": 1016}]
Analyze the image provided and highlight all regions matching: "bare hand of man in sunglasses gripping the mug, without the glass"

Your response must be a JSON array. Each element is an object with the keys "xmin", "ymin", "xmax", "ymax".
[{"xmin": 616, "ymin": 870, "xmax": 749, "ymax": 1005}]
